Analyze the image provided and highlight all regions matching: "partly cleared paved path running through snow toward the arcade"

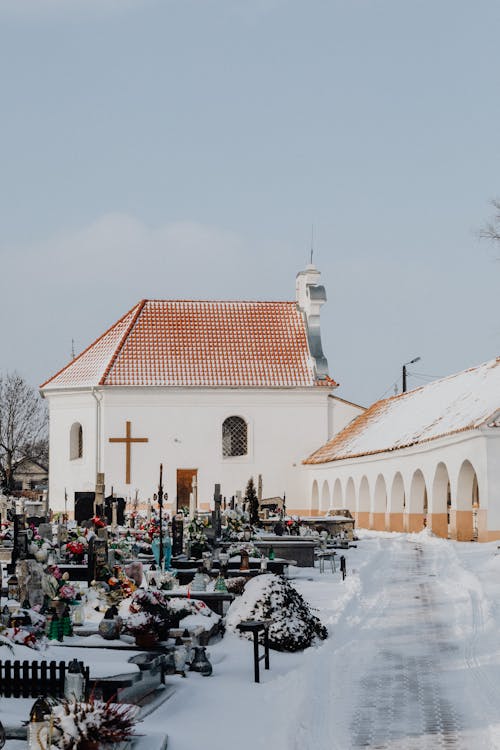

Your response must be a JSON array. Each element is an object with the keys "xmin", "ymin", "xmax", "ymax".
[{"xmin": 328, "ymin": 539, "xmax": 500, "ymax": 750}]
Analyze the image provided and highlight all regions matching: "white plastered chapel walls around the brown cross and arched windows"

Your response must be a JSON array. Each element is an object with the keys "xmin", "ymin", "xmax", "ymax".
[{"xmin": 45, "ymin": 387, "xmax": 340, "ymax": 512}]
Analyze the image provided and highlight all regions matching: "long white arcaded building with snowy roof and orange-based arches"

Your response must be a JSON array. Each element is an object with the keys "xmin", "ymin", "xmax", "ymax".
[{"xmin": 304, "ymin": 358, "xmax": 500, "ymax": 541}]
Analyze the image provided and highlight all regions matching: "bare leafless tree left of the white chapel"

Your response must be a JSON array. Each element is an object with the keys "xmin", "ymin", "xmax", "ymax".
[{"xmin": 0, "ymin": 372, "xmax": 48, "ymax": 491}]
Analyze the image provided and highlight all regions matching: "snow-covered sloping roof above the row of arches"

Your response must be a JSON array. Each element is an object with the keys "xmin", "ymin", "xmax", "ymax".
[{"xmin": 304, "ymin": 357, "xmax": 500, "ymax": 464}]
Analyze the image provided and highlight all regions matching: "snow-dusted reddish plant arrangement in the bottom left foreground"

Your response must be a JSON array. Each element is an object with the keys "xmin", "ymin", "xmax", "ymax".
[{"xmin": 51, "ymin": 698, "xmax": 139, "ymax": 750}]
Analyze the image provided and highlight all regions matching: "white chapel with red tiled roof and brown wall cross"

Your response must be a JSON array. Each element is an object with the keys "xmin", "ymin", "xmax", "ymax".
[{"xmin": 41, "ymin": 265, "xmax": 363, "ymax": 513}]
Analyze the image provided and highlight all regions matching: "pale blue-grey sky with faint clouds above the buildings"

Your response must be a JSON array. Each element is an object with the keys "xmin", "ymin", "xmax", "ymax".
[{"xmin": 0, "ymin": 0, "xmax": 500, "ymax": 404}]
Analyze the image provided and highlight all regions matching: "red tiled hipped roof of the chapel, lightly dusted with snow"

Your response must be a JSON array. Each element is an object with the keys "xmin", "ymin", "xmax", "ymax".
[{"xmin": 41, "ymin": 300, "xmax": 336, "ymax": 390}]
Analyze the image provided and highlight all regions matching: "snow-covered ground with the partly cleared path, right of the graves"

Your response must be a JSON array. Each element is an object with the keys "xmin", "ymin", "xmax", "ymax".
[{"xmin": 146, "ymin": 532, "xmax": 500, "ymax": 750}]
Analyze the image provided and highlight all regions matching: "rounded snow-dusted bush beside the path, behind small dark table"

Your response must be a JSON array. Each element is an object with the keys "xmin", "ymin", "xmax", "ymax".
[{"xmin": 226, "ymin": 574, "xmax": 328, "ymax": 651}]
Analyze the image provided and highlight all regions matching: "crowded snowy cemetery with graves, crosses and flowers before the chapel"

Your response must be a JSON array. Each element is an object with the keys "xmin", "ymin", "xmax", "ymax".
[{"xmin": 0, "ymin": 476, "xmax": 356, "ymax": 750}]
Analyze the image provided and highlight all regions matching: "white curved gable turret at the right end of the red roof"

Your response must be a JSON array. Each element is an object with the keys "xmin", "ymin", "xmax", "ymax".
[{"xmin": 295, "ymin": 263, "xmax": 328, "ymax": 380}]
